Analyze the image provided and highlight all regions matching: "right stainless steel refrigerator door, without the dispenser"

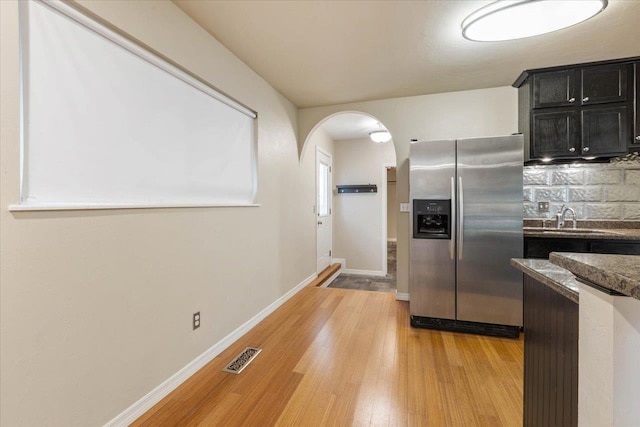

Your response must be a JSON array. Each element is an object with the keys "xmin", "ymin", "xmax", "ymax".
[{"xmin": 458, "ymin": 135, "xmax": 523, "ymax": 326}]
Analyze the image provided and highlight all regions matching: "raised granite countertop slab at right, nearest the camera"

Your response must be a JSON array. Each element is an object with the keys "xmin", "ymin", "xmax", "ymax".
[{"xmin": 549, "ymin": 252, "xmax": 640, "ymax": 300}]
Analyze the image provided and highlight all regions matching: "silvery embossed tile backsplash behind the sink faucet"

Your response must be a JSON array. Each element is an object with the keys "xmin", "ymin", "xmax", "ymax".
[{"xmin": 523, "ymin": 163, "xmax": 640, "ymax": 220}]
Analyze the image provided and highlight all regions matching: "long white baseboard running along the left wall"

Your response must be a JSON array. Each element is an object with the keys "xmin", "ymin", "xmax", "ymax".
[{"xmin": 105, "ymin": 273, "xmax": 318, "ymax": 427}]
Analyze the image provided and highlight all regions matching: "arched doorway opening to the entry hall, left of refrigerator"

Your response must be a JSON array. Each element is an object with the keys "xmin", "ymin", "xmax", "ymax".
[{"xmin": 301, "ymin": 111, "xmax": 398, "ymax": 290}]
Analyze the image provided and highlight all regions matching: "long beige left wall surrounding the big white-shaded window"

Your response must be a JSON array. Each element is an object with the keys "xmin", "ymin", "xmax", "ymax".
[{"xmin": 0, "ymin": 1, "xmax": 315, "ymax": 427}]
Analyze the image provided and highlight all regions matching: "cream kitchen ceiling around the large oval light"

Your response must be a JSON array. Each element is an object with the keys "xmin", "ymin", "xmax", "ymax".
[{"xmin": 174, "ymin": 0, "xmax": 640, "ymax": 107}]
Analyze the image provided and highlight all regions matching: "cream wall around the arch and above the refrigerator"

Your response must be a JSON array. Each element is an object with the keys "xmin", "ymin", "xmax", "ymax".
[{"xmin": 298, "ymin": 87, "xmax": 518, "ymax": 293}]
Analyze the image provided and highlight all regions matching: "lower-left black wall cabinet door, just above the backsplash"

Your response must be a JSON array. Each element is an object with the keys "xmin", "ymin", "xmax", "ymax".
[{"xmin": 531, "ymin": 109, "xmax": 581, "ymax": 159}]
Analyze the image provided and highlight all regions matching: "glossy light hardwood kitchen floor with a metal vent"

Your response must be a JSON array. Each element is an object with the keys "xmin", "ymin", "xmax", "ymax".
[{"xmin": 133, "ymin": 286, "xmax": 523, "ymax": 427}]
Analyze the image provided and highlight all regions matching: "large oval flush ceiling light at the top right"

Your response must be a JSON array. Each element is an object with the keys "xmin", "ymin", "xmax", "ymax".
[{"xmin": 462, "ymin": 0, "xmax": 608, "ymax": 41}]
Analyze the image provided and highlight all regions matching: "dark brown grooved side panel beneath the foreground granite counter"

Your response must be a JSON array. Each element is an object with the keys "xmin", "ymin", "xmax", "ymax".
[{"xmin": 523, "ymin": 274, "xmax": 578, "ymax": 427}]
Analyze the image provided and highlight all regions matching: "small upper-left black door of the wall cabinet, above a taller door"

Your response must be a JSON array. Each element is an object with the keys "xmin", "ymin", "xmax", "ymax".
[{"xmin": 533, "ymin": 70, "xmax": 580, "ymax": 108}]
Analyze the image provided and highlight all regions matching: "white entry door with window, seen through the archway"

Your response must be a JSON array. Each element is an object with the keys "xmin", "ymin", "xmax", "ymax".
[{"xmin": 316, "ymin": 148, "xmax": 332, "ymax": 273}]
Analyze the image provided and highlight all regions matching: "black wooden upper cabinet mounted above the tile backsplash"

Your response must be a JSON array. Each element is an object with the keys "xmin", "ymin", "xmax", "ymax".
[{"xmin": 513, "ymin": 57, "xmax": 640, "ymax": 161}]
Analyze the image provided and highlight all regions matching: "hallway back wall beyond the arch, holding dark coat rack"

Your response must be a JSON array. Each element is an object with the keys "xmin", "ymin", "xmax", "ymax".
[{"xmin": 333, "ymin": 138, "xmax": 396, "ymax": 274}]
